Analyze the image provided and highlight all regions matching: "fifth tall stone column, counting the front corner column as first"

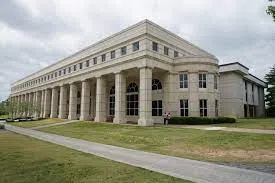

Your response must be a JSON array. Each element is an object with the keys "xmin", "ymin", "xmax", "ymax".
[{"xmin": 68, "ymin": 83, "xmax": 77, "ymax": 120}]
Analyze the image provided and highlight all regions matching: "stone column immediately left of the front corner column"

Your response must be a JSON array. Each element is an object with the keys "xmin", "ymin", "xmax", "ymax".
[{"xmin": 113, "ymin": 72, "xmax": 126, "ymax": 124}]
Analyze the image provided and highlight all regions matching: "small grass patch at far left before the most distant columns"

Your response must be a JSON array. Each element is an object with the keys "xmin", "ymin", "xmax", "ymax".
[{"xmin": 9, "ymin": 118, "xmax": 65, "ymax": 128}]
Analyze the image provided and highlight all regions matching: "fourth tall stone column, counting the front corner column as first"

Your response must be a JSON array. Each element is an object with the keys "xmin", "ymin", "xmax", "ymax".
[{"xmin": 80, "ymin": 81, "xmax": 91, "ymax": 120}]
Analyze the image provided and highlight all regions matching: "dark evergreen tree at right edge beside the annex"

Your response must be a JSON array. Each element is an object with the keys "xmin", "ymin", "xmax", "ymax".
[{"xmin": 265, "ymin": 65, "xmax": 275, "ymax": 117}]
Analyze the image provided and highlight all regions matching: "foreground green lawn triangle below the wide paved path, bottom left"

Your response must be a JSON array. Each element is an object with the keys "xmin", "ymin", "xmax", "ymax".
[{"xmin": 0, "ymin": 131, "xmax": 192, "ymax": 183}]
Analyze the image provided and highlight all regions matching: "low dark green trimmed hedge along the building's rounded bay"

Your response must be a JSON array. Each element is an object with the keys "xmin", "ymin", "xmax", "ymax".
[{"xmin": 169, "ymin": 117, "xmax": 236, "ymax": 125}]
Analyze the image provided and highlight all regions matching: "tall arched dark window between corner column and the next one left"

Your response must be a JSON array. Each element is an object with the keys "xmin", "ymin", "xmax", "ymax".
[{"xmin": 126, "ymin": 83, "xmax": 138, "ymax": 116}]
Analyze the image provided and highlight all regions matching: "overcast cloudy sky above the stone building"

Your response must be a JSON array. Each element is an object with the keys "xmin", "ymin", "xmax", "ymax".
[{"xmin": 0, "ymin": 0, "xmax": 275, "ymax": 101}]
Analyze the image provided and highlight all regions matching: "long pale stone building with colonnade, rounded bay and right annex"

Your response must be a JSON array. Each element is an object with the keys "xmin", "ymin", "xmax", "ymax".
[{"xmin": 10, "ymin": 20, "xmax": 266, "ymax": 126}]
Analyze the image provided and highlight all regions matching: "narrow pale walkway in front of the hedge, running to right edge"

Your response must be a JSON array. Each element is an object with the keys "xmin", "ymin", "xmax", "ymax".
[{"xmin": 168, "ymin": 125, "xmax": 275, "ymax": 134}]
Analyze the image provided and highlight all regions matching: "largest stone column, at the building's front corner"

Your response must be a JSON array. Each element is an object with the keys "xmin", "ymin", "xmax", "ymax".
[{"xmin": 138, "ymin": 67, "xmax": 153, "ymax": 126}]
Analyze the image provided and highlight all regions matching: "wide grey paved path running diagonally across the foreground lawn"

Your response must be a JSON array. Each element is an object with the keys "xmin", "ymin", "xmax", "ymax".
[{"xmin": 5, "ymin": 124, "xmax": 275, "ymax": 183}]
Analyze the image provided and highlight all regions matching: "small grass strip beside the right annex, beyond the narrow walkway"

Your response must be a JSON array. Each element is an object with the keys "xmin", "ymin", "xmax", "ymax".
[{"xmin": 215, "ymin": 118, "xmax": 275, "ymax": 130}]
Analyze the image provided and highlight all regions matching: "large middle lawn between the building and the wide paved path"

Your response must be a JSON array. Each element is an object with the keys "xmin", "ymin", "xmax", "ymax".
[{"xmin": 40, "ymin": 122, "xmax": 275, "ymax": 163}]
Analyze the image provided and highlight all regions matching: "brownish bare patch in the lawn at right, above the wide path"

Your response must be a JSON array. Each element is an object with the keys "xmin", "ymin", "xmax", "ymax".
[{"xmin": 163, "ymin": 144, "xmax": 275, "ymax": 163}]
